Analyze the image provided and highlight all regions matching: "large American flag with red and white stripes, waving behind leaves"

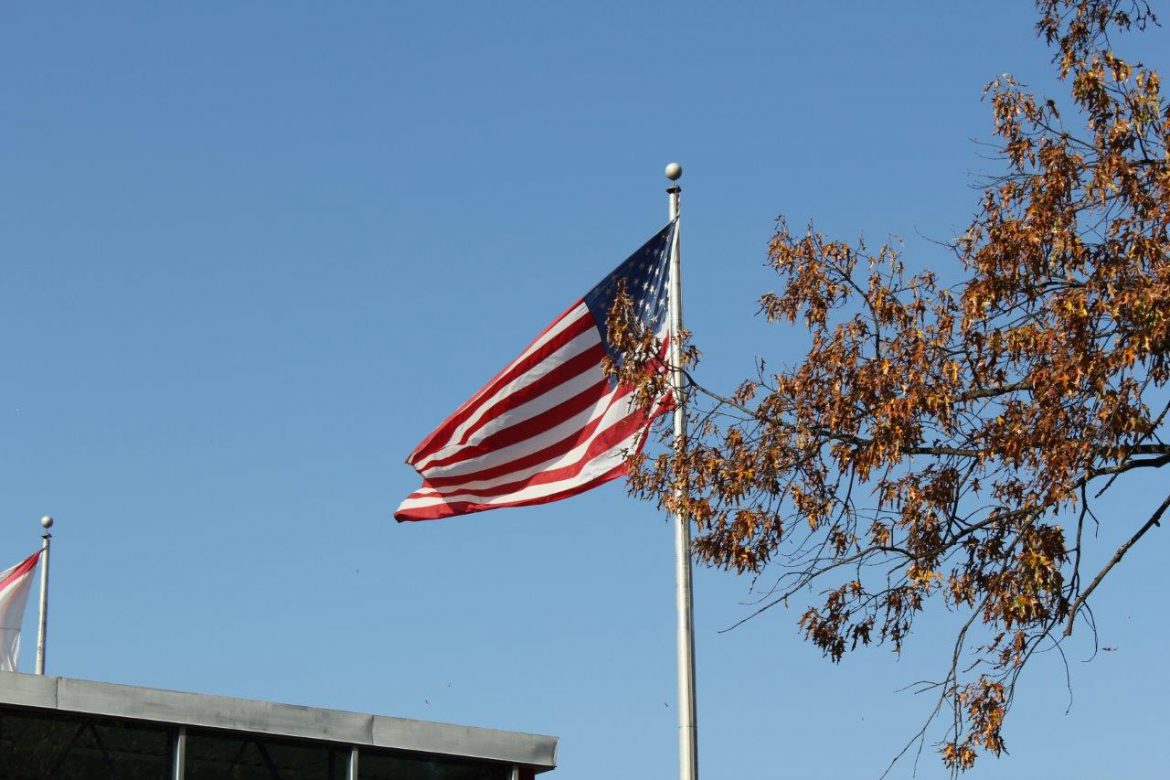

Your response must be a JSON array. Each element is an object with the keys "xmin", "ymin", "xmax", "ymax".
[{"xmin": 394, "ymin": 222, "xmax": 675, "ymax": 520}]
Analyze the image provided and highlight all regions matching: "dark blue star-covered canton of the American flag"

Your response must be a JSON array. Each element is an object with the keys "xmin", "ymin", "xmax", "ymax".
[{"xmin": 585, "ymin": 222, "xmax": 675, "ymax": 376}]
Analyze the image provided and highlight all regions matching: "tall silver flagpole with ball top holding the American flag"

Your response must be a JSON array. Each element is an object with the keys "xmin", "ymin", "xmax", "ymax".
[{"xmin": 666, "ymin": 163, "xmax": 698, "ymax": 780}]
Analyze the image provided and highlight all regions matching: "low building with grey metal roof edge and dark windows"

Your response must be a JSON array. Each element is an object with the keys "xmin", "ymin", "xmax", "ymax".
[{"xmin": 0, "ymin": 672, "xmax": 557, "ymax": 780}]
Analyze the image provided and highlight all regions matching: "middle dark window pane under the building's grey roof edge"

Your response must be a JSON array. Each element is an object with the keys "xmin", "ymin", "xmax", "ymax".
[{"xmin": 186, "ymin": 730, "xmax": 350, "ymax": 780}]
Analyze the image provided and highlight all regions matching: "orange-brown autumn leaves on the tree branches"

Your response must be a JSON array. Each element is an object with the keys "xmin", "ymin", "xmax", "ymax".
[{"xmin": 610, "ymin": 0, "xmax": 1170, "ymax": 771}]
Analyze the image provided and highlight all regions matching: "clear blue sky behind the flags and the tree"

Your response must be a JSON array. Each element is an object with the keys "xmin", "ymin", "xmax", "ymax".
[{"xmin": 0, "ymin": 0, "xmax": 1170, "ymax": 780}]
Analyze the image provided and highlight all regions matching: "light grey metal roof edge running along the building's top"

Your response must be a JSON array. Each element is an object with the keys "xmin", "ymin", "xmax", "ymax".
[{"xmin": 0, "ymin": 672, "xmax": 557, "ymax": 772}]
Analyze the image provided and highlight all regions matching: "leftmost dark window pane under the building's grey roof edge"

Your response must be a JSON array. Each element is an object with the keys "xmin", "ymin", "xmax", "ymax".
[{"xmin": 0, "ymin": 709, "xmax": 171, "ymax": 780}]
